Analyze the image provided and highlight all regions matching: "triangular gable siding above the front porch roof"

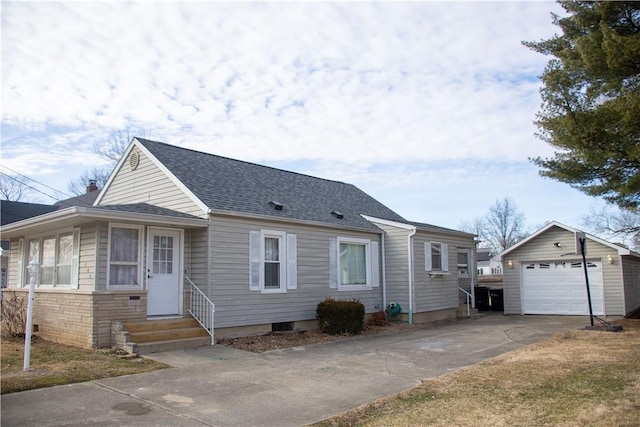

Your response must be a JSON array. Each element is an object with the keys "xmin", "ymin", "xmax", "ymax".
[{"xmin": 100, "ymin": 148, "xmax": 206, "ymax": 218}]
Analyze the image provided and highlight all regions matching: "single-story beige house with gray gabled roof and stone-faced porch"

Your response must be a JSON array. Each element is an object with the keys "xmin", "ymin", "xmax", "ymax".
[{"xmin": 2, "ymin": 138, "xmax": 475, "ymax": 347}]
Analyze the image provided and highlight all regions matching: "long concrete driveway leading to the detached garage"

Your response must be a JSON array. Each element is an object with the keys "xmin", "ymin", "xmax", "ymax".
[{"xmin": 1, "ymin": 313, "xmax": 589, "ymax": 427}]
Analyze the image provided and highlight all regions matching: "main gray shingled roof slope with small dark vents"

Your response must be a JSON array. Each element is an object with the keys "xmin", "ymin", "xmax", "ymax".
[{"xmin": 136, "ymin": 138, "xmax": 405, "ymax": 231}]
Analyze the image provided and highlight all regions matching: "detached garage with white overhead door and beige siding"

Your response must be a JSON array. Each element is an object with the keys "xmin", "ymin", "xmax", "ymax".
[{"xmin": 499, "ymin": 222, "xmax": 640, "ymax": 316}]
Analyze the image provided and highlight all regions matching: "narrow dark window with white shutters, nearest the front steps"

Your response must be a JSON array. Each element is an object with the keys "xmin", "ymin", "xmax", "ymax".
[{"xmin": 249, "ymin": 230, "xmax": 298, "ymax": 293}]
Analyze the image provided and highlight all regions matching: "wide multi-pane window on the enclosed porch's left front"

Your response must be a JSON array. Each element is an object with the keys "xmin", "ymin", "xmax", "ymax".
[{"xmin": 22, "ymin": 230, "xmax": 80, "ymax": 287}]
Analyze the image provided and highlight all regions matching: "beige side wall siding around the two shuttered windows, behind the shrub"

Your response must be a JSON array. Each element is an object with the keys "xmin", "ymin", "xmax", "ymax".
[{"xmin": 209, "ymin": 216, "xmax": 382, "ymax": 328}]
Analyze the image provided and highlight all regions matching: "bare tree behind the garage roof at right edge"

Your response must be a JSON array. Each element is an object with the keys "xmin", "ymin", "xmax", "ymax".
[{"xmin": 582, "ymin": 208, "xmax": 640, "ymax": 250}]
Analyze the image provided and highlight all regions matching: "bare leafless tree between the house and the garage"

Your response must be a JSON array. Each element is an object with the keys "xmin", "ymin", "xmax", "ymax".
[{"xmin": 484, "ymin": 197, "xmax": 529, "ymax": 253}]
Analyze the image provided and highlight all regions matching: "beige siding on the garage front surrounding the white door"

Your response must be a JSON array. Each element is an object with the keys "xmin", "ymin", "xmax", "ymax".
[{"xmin": 502, "ymin": 227, "xmax": 624, "ymax": 316}]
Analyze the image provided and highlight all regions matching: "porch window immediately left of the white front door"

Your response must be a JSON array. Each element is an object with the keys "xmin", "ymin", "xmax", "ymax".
[{"xmin": 108, "ymin": 225, "xmax": 142, "ymax": 287}]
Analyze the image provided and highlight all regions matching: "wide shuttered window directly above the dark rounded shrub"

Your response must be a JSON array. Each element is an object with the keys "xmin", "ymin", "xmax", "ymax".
[{"xmin": 329, "ymin": 237, "xmax": 379, "ymax": 291}]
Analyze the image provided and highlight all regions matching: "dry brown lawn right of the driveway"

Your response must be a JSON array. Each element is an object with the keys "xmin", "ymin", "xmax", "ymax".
[{"xmin": 318, "ymin": 319, "xmax": 640, "ymax": 426}]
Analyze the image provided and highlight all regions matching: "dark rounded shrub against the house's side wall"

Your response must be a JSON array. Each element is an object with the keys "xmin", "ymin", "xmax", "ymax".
[{"xmin": 316, "ymin": 297, "xmax": 364, "ymax": 335}]
